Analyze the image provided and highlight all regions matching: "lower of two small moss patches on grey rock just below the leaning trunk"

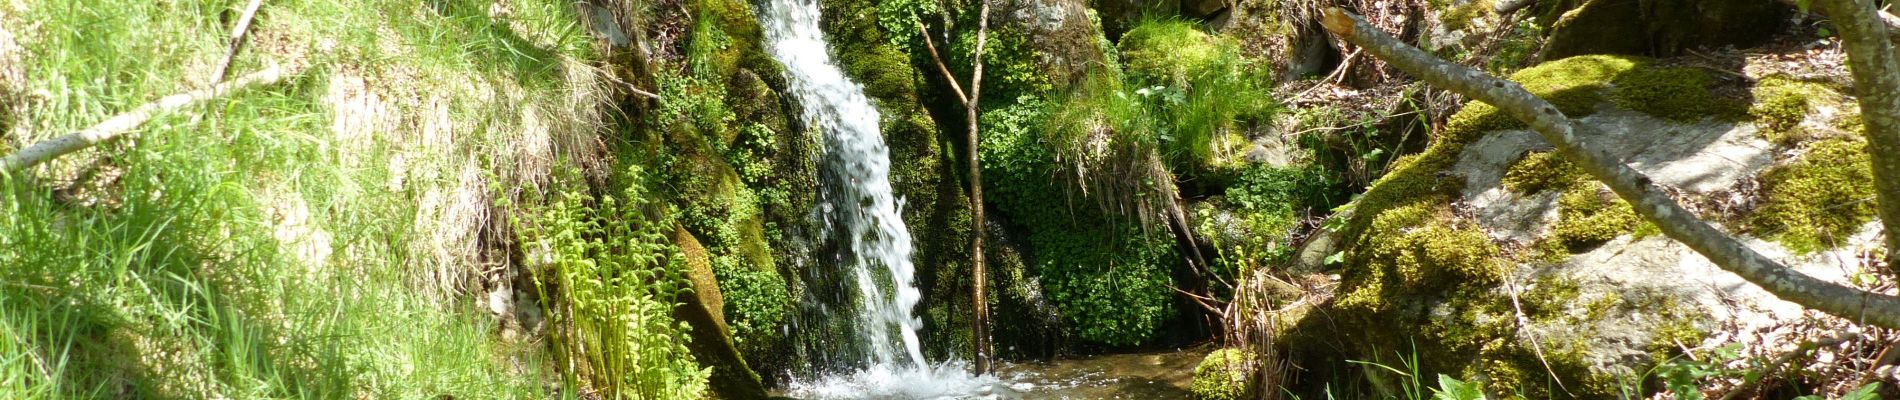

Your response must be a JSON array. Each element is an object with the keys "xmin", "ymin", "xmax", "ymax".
[{"xmin": 1547, "ymin": 180, "xmax": 1642, "ymax": 252}]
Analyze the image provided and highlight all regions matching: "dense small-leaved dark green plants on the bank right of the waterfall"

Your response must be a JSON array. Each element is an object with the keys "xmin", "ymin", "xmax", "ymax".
[{"xmin": 980, "ymin": 97, "xmax": 1178, "ymax": 345}]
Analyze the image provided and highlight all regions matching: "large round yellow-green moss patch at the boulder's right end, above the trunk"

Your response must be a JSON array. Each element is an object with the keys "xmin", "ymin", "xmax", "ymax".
[{"xmin": 1750, "ymin": 138, "xmax": 1873, "ymax": 252}]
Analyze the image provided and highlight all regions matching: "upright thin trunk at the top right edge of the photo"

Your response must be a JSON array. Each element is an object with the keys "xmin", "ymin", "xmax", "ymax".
[{"xmin": 1820, "ymin": 0, "xmax": 1900, "ymax": 267}]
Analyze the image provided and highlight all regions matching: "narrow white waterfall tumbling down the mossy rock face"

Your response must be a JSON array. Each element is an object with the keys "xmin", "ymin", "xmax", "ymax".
[{"xmin": 762, "ymin": 0, "xmax": 1018, "ymax": 398}]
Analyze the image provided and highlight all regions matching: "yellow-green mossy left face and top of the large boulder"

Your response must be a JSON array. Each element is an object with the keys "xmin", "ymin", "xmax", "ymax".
[{"xmin": 1288, "ymin": 55, "xmax": 1739, "ymax": 398}]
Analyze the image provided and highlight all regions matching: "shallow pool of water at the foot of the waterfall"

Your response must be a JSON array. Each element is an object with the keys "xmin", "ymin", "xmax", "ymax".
[{"xmin": 783, "ymin": 347, "xmax": 1212, "ymax": 400}]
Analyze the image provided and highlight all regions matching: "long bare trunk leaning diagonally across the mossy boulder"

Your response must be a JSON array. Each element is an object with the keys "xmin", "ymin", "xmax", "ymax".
[{"xmin": 1322, "ymin": 8, "xmax": 1900, "ymax": 328}]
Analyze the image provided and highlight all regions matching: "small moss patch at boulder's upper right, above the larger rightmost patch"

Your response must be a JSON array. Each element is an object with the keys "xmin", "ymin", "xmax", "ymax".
[{"xmin": 1748, "ymin": 76, "xmax": 1854, "ymax": 146}]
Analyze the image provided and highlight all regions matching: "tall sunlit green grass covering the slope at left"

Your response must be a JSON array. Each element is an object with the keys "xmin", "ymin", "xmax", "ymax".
[{"xmin": 0, "ymin": 0, "xmax": 668, "ymax": 398}]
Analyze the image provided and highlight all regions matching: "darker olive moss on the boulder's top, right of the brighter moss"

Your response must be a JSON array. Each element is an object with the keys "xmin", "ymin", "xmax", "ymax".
[{"xmin": 1611, "ymin": 66, "xmax": 1744, "ymax": 121}]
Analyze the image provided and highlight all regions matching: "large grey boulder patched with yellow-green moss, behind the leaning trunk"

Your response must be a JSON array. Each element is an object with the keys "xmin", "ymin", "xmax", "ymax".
[{"xmin": 1288, "ymin": 57, "xmax": 1879, "ymax": 398}]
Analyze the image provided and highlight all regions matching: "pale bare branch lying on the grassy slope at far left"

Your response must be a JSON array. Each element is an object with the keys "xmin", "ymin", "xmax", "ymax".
[{"xmin": 0, "ymin": 66, "xmax": 289, "ymax": 174}]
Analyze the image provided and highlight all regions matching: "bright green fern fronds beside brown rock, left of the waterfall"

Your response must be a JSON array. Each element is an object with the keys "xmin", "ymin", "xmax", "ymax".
[{"xmin": 517, "ymin": 169, "xmax": 711, "ymax": 398}]
